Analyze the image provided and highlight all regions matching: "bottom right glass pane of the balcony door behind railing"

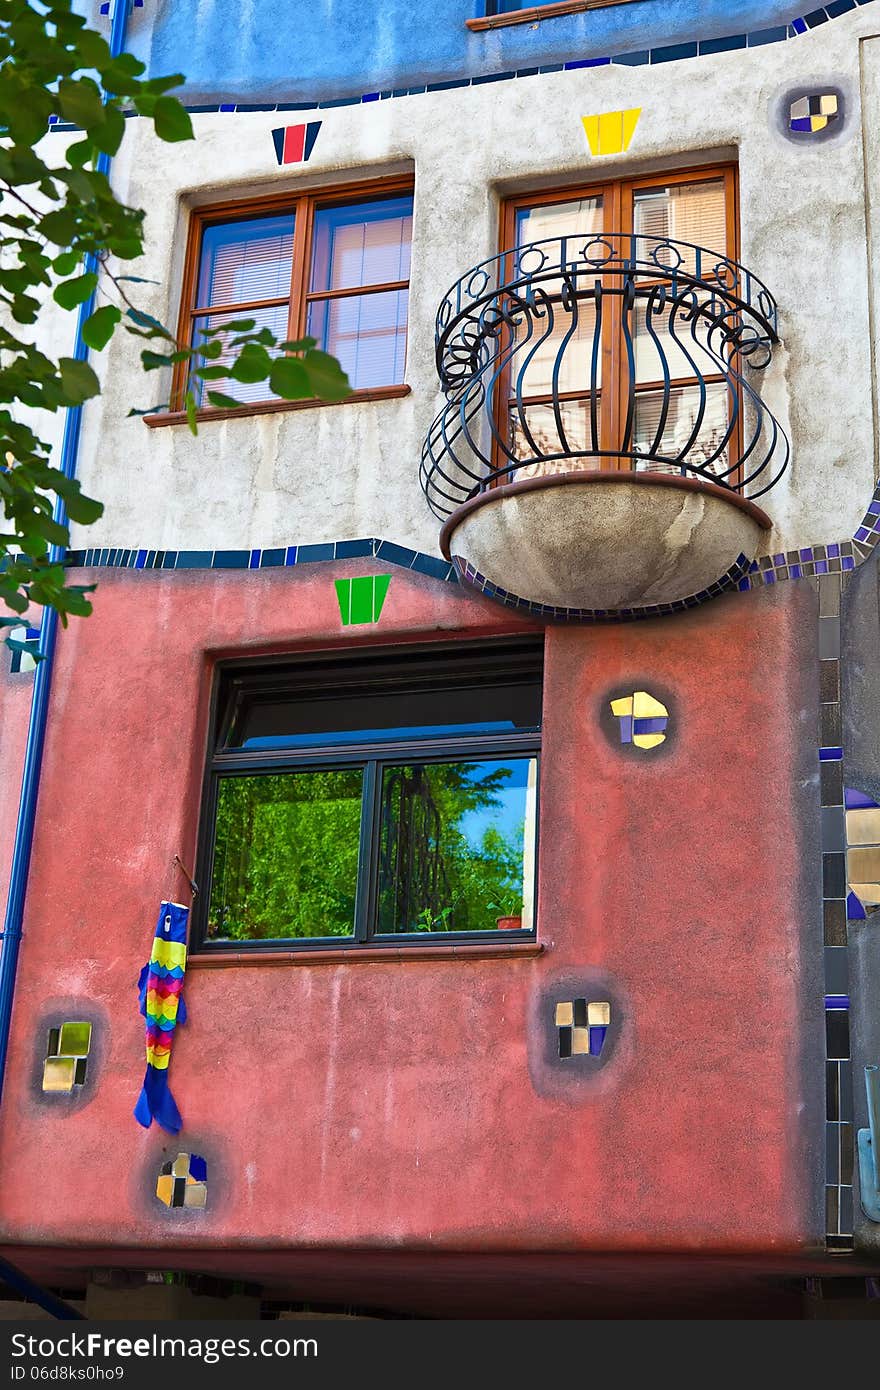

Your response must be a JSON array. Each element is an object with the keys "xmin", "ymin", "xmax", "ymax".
[{"xmin": 634, "ymin": 382, "xmax": 730, "ymax": 474}]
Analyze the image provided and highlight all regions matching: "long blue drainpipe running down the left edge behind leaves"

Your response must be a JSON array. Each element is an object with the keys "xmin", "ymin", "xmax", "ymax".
[{"xmin": 0, "ymin": 0, "xmax": 129, "ymax": 1099}]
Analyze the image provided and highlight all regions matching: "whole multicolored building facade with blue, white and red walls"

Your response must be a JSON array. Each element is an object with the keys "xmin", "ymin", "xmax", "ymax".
[{"xmin": 0, "ymin": 0, "xmax": 880, "ymax": 1315}]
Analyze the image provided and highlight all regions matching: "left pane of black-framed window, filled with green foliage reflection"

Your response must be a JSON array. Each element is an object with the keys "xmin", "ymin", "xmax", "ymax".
[{"xmin": 207, "ymin": 769, "xmax": 363, "ymax": 941}]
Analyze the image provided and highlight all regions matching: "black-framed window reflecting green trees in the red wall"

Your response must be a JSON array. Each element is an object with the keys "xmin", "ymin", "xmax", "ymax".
[{"xmin": 196, "ymin": 641, "xmax": 542, "ymax": 951}]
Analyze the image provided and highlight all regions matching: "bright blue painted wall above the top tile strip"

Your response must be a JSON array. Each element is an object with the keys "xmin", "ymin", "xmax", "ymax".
[{"xmin": 140, "ymin": 0, "xmax": 810, "ymax": 103}]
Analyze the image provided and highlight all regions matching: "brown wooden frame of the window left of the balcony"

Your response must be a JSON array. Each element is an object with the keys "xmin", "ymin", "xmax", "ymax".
[{"xmin": 168, "ymin": 174, "xmax": 416, "ymax": 424}]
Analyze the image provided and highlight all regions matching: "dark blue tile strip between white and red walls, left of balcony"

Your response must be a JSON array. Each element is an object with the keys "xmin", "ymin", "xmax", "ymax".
[{"xmin": 65, "ymin": 537, "xmax": 459, "ymax": 584}]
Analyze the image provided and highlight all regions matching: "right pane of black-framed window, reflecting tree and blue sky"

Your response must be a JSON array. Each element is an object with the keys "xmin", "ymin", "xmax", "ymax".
[{"xmin": 377, "ymin": 758, "xmax": 537, "ymax": 935}]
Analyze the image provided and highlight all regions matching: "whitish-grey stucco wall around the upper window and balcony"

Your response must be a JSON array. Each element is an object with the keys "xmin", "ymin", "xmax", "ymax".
[{"xmin": 67, "ymin": 6, "xmax": 880, "ymax": 552}]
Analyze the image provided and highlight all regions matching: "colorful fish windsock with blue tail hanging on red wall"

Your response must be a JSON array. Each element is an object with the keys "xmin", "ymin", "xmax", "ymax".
[{"xmin": 135, "ymin": 902, "xmax": 189, "ymax": 1134}]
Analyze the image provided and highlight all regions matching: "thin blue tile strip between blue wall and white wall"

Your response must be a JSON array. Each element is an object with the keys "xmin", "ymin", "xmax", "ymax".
[{"xmin": 41, "ymin": 0, "xmax": 874, "ymax": 131}]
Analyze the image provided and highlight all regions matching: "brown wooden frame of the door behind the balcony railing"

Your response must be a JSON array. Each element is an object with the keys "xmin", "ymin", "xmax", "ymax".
[{"xmin": 494, "ymin": 163, "xmax": 742, "ymax": 475}]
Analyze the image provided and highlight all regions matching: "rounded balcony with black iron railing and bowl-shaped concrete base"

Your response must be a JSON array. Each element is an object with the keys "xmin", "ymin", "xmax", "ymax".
[{"xmin": 420, "ymin": 234, "xmax": 788, "ymax": 617}]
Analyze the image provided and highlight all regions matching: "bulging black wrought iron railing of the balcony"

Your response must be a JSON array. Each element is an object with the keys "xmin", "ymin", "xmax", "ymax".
[{"xmin": 420, "ymin": 232, "xmax": 788, "ymax": 516}]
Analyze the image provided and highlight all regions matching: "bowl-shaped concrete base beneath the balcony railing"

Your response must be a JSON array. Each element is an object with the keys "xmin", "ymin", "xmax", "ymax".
[{"xmin": 441, "ymin": 470, "xmax": 772, "ymax": 617}]
